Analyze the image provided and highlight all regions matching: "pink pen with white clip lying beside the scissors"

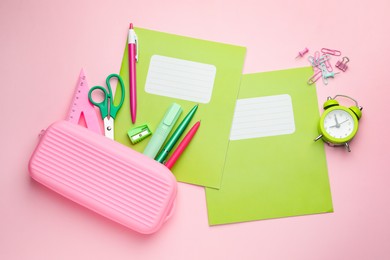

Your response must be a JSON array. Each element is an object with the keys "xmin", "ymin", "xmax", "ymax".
[{"xmin": 128, "ymin": 23, "xmax": 138, "ymax": 124}]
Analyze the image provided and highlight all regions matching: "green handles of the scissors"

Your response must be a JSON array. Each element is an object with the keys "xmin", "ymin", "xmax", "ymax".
[{"xmin": 88, "ymin": 74, "xmax": 125, "ymax": 119}]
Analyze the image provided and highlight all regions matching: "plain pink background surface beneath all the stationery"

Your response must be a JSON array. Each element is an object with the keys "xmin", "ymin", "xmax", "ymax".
[{"xmin": 0, "ymin": 0, "xmax": 390, "ymax": 260}]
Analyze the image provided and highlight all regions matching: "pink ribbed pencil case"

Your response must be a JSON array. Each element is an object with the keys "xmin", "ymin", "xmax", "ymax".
[{"xmin": 29, "ymin": 121, "xmax": 177, "ymax": 234}]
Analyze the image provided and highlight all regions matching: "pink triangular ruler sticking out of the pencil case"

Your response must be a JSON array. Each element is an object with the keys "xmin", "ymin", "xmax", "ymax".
[{"xmin": 67, "ymin": 69, "xmax": 102, "ymax": 134}]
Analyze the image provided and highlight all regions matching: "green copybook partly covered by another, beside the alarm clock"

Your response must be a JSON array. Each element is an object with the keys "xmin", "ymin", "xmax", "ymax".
[{"xmin": 206, "ymin": 68, "xmax": 333, "ymax": 225}]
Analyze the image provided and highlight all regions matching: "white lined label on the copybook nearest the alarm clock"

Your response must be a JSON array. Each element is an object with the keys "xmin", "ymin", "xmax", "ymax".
[{"xmin": 230, "ymin": 94, "xmax": 295, "ymax": 140}]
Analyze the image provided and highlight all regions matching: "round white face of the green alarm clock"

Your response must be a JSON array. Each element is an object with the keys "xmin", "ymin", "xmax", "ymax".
[{"xmin": 324, "ymin": 109, "xmax": 355, "ymax": 139}]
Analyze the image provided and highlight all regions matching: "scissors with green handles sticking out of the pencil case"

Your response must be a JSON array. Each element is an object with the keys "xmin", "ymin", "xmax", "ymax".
[{"xmin": 88, "ymin": 74, "xmax": 125, "ymax": 140}]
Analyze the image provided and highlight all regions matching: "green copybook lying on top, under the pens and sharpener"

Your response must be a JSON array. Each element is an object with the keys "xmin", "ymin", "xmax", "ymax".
[{"xmin": 115, "ymin": 28, "xmax": 246, "ymax": 188}]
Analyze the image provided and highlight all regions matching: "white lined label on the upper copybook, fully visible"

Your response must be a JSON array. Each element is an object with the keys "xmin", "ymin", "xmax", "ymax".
[{"xmin": 145, "ymin": 55, "xmax": 217, "ymax": 103}]
